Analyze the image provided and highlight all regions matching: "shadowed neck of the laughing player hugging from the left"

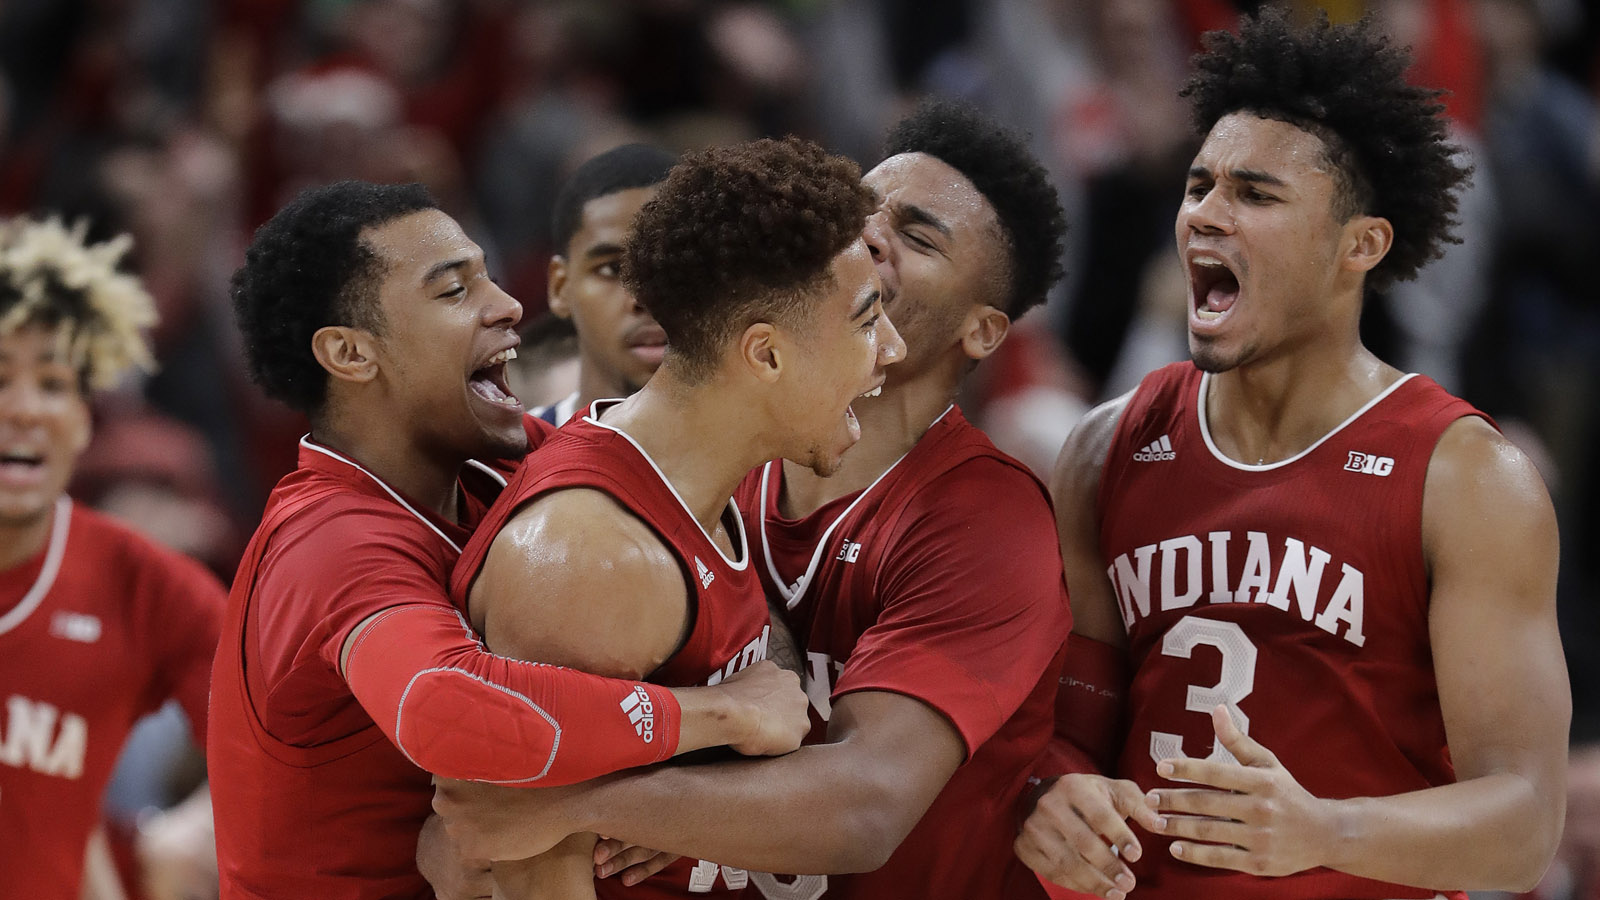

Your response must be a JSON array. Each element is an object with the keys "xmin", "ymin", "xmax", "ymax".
[{"xmin": 310, "ymin": 416, "xmax": 466, "ymax": 522}]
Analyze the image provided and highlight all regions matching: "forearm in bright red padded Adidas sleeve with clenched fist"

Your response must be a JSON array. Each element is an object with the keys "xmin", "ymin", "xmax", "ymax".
[{"xmin": 339, "ymin": 573, "xmax": 798, "ymax": 786}]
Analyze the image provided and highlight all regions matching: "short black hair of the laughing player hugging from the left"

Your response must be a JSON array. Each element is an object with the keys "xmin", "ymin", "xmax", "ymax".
[{"xmin": 232, "ymin": 181, "xmax": 438, "ymax": 415}]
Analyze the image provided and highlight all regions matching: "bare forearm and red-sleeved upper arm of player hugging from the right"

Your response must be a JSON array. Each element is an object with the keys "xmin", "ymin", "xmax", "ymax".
[{"xmin": 435, "ymin": 464, "xmax": 1066, "ymax": 873}]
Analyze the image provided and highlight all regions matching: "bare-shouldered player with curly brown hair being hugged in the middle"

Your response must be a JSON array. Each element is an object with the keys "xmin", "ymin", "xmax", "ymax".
[{"xmin": 453, "ymin": 138, "xmax": 904, "ymax": 897}]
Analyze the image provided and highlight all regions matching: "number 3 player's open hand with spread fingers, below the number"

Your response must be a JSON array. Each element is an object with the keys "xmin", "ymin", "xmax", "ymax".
[{"xmin": 1146, "ymin": 706, "xmax": 1338, "ymax": 876}]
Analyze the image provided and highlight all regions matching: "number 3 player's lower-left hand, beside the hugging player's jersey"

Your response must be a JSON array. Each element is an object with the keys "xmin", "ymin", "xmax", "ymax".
[{"xmin": 1014, "ymin": 762, "xmax": 1155, "ymax": 900}]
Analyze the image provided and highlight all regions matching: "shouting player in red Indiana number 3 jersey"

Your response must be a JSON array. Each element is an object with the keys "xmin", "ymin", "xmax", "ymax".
[{"xmin": 1018, "ymin": 11, "xmax": 1571, "ymax": 898}]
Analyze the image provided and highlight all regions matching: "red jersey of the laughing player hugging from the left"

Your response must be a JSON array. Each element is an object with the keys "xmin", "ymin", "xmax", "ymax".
[{"xmin": 206, "ymin": 440, "xmax": 521, "ymax": 900}]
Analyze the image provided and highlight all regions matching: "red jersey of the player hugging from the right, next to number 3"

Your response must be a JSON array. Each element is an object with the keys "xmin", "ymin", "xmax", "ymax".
[{"xmin": 738, "ymin": 407, "xmax": 1072, "ymax": 900}]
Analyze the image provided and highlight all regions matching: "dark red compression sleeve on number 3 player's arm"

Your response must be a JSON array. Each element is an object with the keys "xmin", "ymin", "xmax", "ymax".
[{"xmin": 1037, "ymin": 634, "xmax": 1130, "ymax": 777}]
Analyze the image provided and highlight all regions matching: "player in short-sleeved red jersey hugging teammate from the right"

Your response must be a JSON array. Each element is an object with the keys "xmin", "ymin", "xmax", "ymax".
[{"xmin": 438, "ymin": 102, "xmax": 1070, "ymax": 900}]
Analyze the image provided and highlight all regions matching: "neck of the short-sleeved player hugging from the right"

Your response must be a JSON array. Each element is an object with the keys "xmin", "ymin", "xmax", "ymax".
[{"xmin": 778, "ymin": 368, "xmax": 955, "ymax": 519}]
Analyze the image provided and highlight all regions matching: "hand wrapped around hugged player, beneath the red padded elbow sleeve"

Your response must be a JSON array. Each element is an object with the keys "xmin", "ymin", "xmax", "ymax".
[{"xmin": 434, "ymin": 778, "xmax": 592, "ymax": 860}]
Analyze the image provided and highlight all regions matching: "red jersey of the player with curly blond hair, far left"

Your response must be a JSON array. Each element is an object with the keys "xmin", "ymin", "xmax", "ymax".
[{"xmin": 0, "ymin": 498, "xmax": 224, "ymax": 900}]
